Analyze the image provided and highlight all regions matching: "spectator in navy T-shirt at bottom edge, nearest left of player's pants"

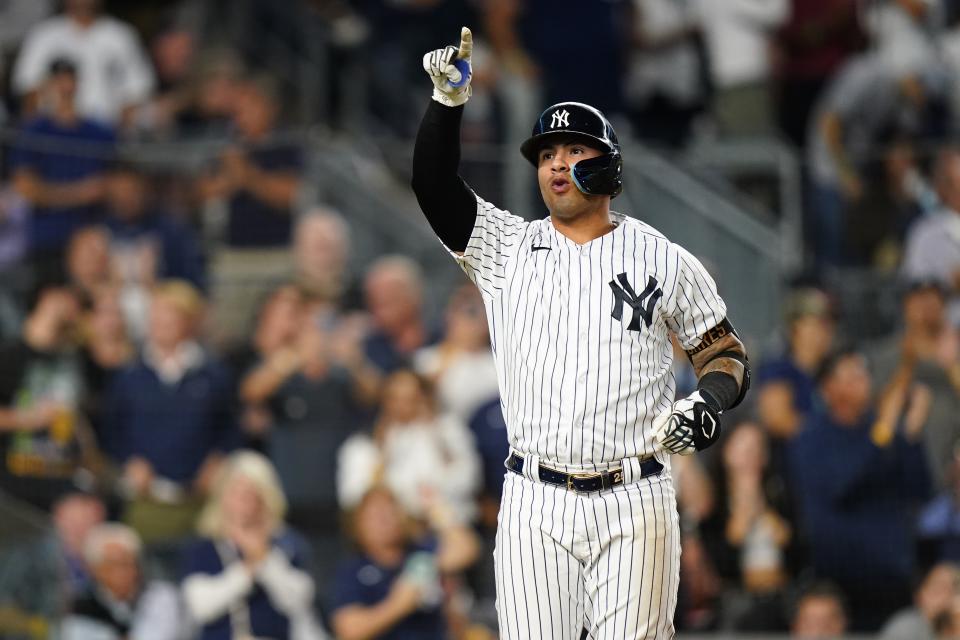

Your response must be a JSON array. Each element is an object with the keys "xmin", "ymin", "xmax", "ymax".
[{"xmin": 331, "ymin": 488, "xmax": 477, "ymax": 640}]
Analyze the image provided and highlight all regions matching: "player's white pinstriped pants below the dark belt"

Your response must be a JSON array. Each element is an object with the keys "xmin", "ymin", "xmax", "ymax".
[{"xmin": 494, "ymin": 471, "xmax": 680, "ymax": 640}]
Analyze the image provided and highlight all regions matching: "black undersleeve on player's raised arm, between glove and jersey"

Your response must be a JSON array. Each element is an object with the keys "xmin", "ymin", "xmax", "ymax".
[{"xmin": 411, "ymin": 100, "xmax": 477, "ymax": 251}]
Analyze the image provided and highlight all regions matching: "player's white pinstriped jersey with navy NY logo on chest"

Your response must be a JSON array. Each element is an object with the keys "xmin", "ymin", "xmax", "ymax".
[{"xmin": 453, "ymin": 192, "xmax": 726, "ymax": 469}]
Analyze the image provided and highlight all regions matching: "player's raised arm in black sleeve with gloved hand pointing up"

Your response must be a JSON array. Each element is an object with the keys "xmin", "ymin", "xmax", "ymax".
[{"xmin": 411, "ymin": 27, "xmax": 477, "ymax": 252}]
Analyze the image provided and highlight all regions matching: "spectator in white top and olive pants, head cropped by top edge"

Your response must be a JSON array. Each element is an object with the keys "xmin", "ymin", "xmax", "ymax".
[{"xmin": 699, "ymin": 0, "xmax": 790, "ymax": 136}]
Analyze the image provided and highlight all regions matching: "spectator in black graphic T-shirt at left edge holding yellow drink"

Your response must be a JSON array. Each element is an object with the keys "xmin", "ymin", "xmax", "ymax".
[{"xmin": 0, "ymin": 288, "xmax": 92, "ymax": 509}]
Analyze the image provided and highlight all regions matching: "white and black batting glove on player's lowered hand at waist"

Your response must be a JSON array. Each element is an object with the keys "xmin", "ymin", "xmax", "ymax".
[{"xmin": 653, "ymin": 390, "xmax": 720, "ymax": 456}]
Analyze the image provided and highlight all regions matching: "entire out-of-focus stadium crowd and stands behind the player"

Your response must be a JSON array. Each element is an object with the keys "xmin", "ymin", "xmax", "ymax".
[{"xmin": 0, "ymin": 0, "xmax": 960, "ymax": 640}]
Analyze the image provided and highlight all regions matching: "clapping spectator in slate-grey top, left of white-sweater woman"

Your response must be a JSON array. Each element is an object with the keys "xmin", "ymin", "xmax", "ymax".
[{"xmin": 234, "ymin": 285, "xmax": 370, "ymax": 597}]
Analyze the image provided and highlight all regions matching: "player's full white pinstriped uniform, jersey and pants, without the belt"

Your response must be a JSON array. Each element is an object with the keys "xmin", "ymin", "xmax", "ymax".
[{"xmin": 442, "ymin": 198, "xmax": 726, "ymax": 640}]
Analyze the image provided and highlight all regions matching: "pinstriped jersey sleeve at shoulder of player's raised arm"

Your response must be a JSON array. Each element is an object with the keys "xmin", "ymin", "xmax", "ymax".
[{"xmin": 447, "ymin": 196, "xmax": 529, "ymax": 298}]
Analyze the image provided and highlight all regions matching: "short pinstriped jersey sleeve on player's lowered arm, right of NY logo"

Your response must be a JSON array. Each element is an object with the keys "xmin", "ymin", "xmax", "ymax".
[{"xmin": 667, "ymin": 245, "xmax": 727, "ymax": 351}]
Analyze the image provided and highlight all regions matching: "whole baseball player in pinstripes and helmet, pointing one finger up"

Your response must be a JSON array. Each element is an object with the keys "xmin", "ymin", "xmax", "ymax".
[{"xmin": 413, "ymin": 28, "xmax": 749, "ymax": 640}]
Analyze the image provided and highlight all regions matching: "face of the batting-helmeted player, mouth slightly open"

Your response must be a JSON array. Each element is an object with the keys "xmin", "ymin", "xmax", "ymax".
[{"xmin": 537, "ymin": 141, "xmax": 608, "ymax": 220}]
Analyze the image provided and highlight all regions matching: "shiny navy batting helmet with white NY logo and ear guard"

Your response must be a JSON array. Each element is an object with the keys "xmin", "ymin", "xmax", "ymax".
[{"xmin": 520, "ymin": 102, "xmax": 623, "ymax": 198}]
